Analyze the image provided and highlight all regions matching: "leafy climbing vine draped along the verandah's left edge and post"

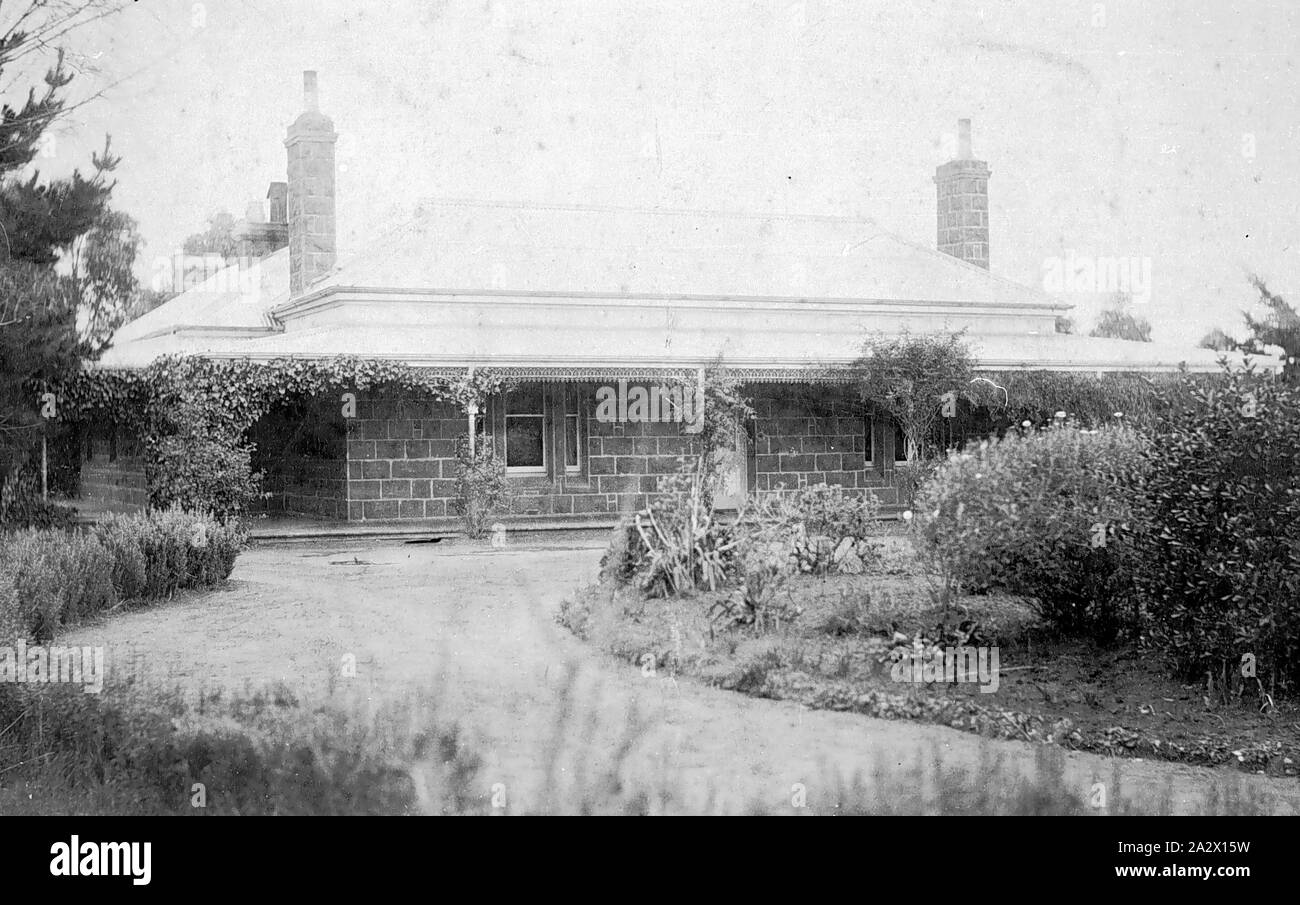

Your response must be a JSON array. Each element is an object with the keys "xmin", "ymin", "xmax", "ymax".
[{"xmin": 56, "ymin": 356, "xmax": 510, "ymax": 518}]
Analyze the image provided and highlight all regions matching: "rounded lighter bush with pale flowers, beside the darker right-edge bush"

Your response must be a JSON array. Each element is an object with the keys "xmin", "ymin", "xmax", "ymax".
[{"xmin": 913, "ymin": 424, "xmax": 1144, "ymax": 640}]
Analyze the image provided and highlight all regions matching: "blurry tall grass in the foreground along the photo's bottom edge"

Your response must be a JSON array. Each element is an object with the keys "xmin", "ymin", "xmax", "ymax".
[{"xmin": 0, "ymin": 670, "xmax": 1261, "ymax": 815}]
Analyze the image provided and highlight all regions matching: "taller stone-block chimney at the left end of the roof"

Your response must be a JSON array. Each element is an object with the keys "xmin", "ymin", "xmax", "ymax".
[{"xmin": 284, "ymin": 72, "xmax": 338, "ymax": 296}]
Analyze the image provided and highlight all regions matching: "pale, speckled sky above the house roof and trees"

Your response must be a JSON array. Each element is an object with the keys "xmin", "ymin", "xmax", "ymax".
[{"xmin": 7, "ymin": 0, "xmax": 1300, "ymax": 343}]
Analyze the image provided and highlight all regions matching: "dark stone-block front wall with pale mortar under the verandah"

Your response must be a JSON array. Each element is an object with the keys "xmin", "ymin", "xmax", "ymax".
[{"xmin": 346, "ymin": 385, "xmax": 897, "ymax": 521}]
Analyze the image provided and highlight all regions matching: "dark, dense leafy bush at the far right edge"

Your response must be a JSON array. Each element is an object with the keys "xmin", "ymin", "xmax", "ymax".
[{"xmin": 1135, "ymin": 372, "xmax": 1300, "ymax": 687}]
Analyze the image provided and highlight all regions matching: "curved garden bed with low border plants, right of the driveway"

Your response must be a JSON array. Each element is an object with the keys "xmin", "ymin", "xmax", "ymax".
[{"xmin": 559, "ymin": 537, "xmax": 1300, "ymax": 775}]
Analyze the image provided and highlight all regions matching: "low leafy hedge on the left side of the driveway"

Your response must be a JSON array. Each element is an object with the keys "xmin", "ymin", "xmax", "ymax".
[{"xmin": 0, "ymin": 510, "xmax": 246, "ymax": 641}]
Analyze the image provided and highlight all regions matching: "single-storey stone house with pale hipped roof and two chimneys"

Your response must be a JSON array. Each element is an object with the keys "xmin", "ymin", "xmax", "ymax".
[{"xmin": 83, "ymin": 73, "xmax": 1248, "ymax": 524}]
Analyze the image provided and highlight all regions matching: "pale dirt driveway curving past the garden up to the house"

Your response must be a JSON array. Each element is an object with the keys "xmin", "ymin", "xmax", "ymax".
[{"xmin": 68, "ymin": 541, "xmax": 1300, "ymax": 814}]
